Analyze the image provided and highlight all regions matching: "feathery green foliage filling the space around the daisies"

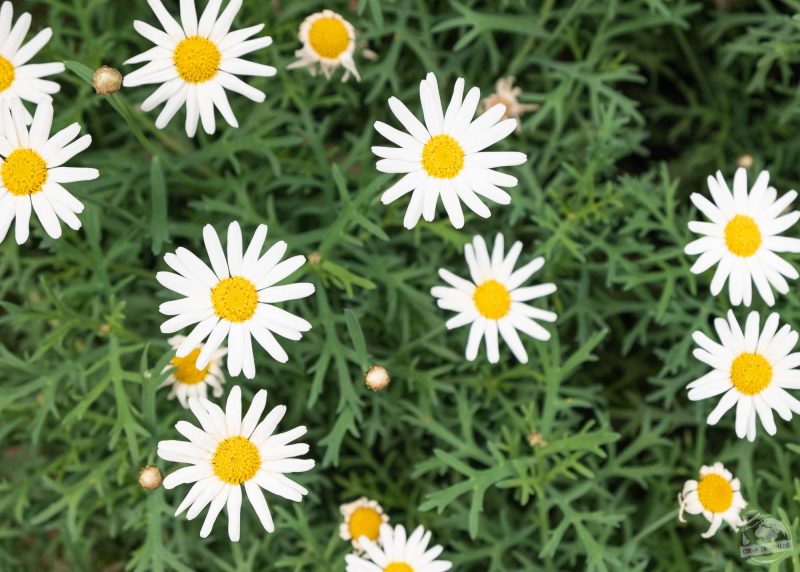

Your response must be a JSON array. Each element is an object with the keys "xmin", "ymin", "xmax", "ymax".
[{"xmin": 0, "ymin": 0, "xmax": 800, "ymax": 572}]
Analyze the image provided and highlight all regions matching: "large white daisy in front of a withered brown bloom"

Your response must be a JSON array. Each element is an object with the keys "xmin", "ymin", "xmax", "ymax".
[{"xmin": 372, "ymin": 73, "xmax": 527, "ymax": 228}]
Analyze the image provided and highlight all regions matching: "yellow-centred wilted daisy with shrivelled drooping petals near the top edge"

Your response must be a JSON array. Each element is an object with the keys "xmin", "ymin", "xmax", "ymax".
[{"xmin": 288, "ymin": 10, "xmax": 361, "ymax": 81}]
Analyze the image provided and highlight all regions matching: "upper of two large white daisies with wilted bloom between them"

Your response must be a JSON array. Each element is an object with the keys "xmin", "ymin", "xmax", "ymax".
[{"xmin": 156, "ymin": 221, "xmax": 314, "ymax": 379}]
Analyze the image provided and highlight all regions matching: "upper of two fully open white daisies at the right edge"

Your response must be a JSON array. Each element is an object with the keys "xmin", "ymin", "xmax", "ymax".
[{"xmin": 684, "ymin": 169, "xmax": 800, "ymax": 306}]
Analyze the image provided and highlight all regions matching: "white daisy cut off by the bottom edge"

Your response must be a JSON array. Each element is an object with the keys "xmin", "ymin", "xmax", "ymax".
[{"xmin": 346, "ymin": 524, "xmax": 453, "ymax": 572}]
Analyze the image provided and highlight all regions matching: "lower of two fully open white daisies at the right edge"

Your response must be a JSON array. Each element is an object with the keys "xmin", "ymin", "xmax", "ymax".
[{"xmin": 688, "ymin": 311, "xmax": 800, "ymax": 441}]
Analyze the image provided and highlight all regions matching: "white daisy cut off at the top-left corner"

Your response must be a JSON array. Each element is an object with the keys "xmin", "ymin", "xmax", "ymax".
[{"xmin": 0, "ymin": 2, "xmax": 64, "ymax": 125}]
